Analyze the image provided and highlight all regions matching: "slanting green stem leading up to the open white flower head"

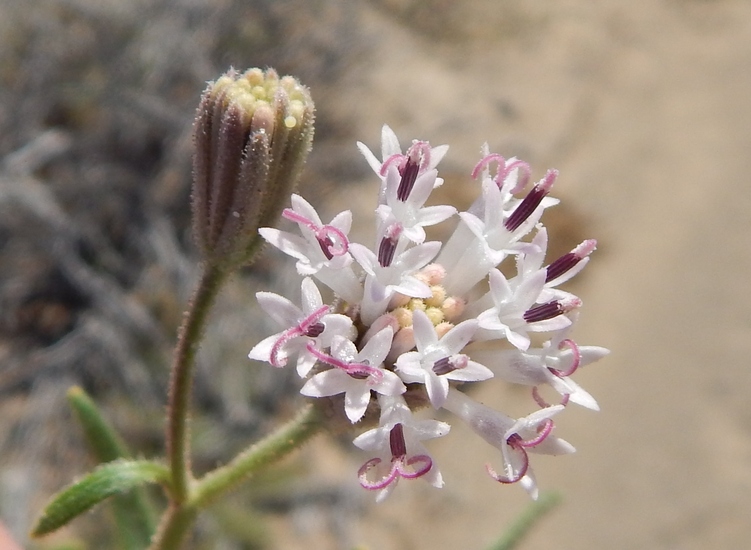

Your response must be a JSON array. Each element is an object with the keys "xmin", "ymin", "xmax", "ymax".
[{"xmin": 191, "ymin": 404, "xmax": 323, "ymax": 507}]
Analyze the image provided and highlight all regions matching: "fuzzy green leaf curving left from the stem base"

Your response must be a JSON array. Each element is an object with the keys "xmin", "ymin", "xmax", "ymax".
[{"xmin": 31, "ymin": 460, "xmax": 169, "ymax": 537}]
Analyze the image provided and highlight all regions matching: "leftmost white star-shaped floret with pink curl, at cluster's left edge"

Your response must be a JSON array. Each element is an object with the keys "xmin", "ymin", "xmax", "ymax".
[{"xmin": 248, "ymin": 277, "xmax": 352, "ymax": 376}]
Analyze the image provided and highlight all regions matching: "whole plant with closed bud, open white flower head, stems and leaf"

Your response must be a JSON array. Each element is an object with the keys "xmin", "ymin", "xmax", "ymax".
[{"xmin": 34, "ymin": 69, "xmax": 608, "ymax": 550}]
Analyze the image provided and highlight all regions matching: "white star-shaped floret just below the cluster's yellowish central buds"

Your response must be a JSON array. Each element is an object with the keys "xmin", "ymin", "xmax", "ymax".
[{"xmin": 396, "ymin": 310, "xmax": 493, "ymax": 409}]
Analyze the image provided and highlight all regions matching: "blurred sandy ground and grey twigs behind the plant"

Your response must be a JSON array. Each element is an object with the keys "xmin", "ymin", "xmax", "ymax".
[{"xmin": 0, "ymin": 0, "xmax": 751, "ymax": 550}]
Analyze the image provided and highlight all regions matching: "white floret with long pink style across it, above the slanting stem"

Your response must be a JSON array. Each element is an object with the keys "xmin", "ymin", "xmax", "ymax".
[{"xmin": 300, "ymin": 327, "xmax": 406, "ymax": 423}]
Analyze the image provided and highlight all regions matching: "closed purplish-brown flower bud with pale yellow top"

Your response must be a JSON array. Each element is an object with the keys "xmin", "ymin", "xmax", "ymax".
[{"xmin": 192, "ymin": 69, "xmax": 314, "ymax": 269}]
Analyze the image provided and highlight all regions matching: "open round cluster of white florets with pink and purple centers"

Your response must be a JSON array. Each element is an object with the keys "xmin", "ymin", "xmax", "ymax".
[{"xmin": 249, "ymin": 126, "xmax": 608, "ymax": 500}]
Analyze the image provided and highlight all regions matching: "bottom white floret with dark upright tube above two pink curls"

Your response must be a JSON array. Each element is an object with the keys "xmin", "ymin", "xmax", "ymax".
[{"xmin": 353, "ymin": 396, "xmax": 451, "ymax": 502}]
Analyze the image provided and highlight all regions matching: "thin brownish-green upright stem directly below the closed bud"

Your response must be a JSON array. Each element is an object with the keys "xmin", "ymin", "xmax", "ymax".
[{"xmin": 167, "ymin": 263, "xmax": 226, "ymax": 504}]
